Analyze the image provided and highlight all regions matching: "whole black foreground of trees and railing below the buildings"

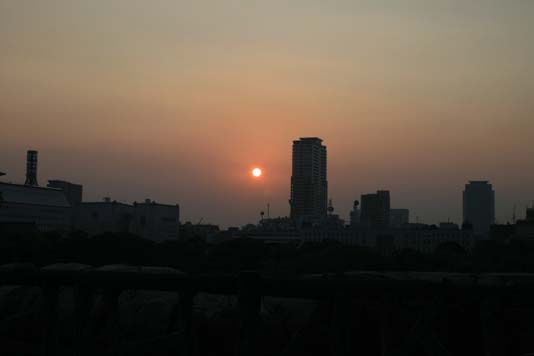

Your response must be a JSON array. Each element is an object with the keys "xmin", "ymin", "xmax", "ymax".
[{"xmin": 0, "ymin": 229, "xmax": 534, "ymax": 355}]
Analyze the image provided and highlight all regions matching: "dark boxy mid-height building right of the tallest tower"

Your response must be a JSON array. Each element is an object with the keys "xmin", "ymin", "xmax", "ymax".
[{"xmin": 360, "ymin": 190, "xmax": 390, "ymax": 227}]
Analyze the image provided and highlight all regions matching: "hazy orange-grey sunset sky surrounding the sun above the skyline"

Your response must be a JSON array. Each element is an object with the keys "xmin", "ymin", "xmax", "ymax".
[{"xmin": 0, "ymin": 0, "xmax": 534, "ymax": 226}]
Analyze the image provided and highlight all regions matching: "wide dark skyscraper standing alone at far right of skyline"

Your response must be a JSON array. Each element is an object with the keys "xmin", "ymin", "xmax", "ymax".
[{"xmin": 463, "ymin": 181, "xmax": 495, "ymax": 236}]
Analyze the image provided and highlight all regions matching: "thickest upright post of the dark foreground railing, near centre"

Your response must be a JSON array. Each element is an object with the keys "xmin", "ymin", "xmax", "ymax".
[{"xmin": 238, "ymin": 271, "xmax": 262, "ymax": 356}]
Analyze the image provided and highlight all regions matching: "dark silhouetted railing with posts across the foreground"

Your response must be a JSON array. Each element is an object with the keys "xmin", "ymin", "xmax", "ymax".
[{"xmin": 0, "ymin": 264, "xmax": 534, "ymax": 355}]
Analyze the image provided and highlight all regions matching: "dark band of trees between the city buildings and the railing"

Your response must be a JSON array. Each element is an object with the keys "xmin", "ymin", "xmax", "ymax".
[{"xmin": 0, "ymin": 232, "xmax": 534, "ymax": 275}]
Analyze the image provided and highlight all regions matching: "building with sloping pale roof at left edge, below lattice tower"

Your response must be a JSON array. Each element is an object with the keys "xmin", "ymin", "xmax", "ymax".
[{"xmin": 0, "ymin": 182, "xmax": 71, "ymax": 232}]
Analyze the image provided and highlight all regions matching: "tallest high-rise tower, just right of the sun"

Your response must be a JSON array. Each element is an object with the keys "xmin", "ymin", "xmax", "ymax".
[{"xmin": 289, "ymin": 137, "xmax": 328, "ymax": 226}]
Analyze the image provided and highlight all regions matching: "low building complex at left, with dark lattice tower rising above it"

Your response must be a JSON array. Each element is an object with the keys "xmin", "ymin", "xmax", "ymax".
[{"xmin": 0, "ymin": 150, "xmax": 180, "ymax": 241}]
